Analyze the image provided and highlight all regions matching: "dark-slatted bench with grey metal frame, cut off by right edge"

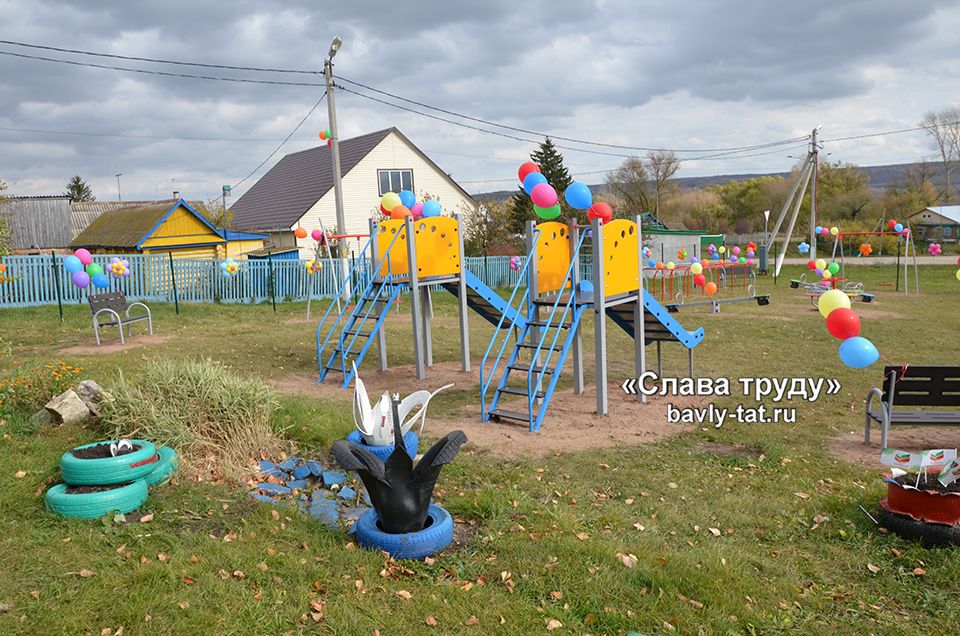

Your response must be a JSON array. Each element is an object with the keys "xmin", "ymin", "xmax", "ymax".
[{"xmin": 864, "ymin": 366, "xmax": 960, "ymax": 448}]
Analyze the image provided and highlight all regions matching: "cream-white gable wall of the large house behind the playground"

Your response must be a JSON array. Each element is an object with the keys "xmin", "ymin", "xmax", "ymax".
[{"xmin": 291, "ymin": 133, "xmax": 476, "ymax": 258}]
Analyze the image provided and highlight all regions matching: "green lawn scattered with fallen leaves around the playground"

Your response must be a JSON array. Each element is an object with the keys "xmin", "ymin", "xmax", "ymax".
[{"xmin": 0, "ymin": 267, "xmax": 960, "ymax": 634}]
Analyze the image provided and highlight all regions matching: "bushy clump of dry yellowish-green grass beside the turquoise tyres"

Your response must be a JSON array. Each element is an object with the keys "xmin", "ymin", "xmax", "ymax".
[{"xmin": 102, "ymin": 360, "xmax": 284, "ymax": 480}]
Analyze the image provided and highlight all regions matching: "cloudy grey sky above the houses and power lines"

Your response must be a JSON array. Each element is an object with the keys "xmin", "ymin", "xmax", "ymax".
[{"xmin": 0, "ymin": 0, "xmax": 960, "ymax": 204}]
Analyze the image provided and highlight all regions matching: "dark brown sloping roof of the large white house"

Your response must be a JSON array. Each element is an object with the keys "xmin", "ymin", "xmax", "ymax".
[{"xmin": 230, "ymin": 128, "xmax": 400, "ymax": 230}]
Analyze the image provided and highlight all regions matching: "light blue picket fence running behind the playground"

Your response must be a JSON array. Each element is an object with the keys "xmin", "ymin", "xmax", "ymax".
[{"xmin": 0, "ymin": 254, "xmax": 517, "ymax": 309}]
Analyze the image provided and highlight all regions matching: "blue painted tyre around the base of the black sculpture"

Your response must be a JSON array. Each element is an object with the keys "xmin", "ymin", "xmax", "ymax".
[{"xmin": 353, "ymin": 504, "xmax": 453, "ymax": 559}]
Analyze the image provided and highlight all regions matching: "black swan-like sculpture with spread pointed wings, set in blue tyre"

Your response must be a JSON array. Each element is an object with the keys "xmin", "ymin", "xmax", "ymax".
[{"xmin": 332, "ymin": 397, "xmax": 467, "ymax": 534}]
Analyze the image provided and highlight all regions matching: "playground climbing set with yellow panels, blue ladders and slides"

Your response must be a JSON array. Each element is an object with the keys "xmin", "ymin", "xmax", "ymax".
[{"xmin": 316, "ymin": 217, "xmax": 704, "ymax": 431}]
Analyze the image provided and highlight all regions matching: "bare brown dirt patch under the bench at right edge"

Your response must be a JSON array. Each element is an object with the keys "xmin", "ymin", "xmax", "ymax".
[{"xmin": 827, "ymin": 426, "xmax": 960, "ymax": 468}]
